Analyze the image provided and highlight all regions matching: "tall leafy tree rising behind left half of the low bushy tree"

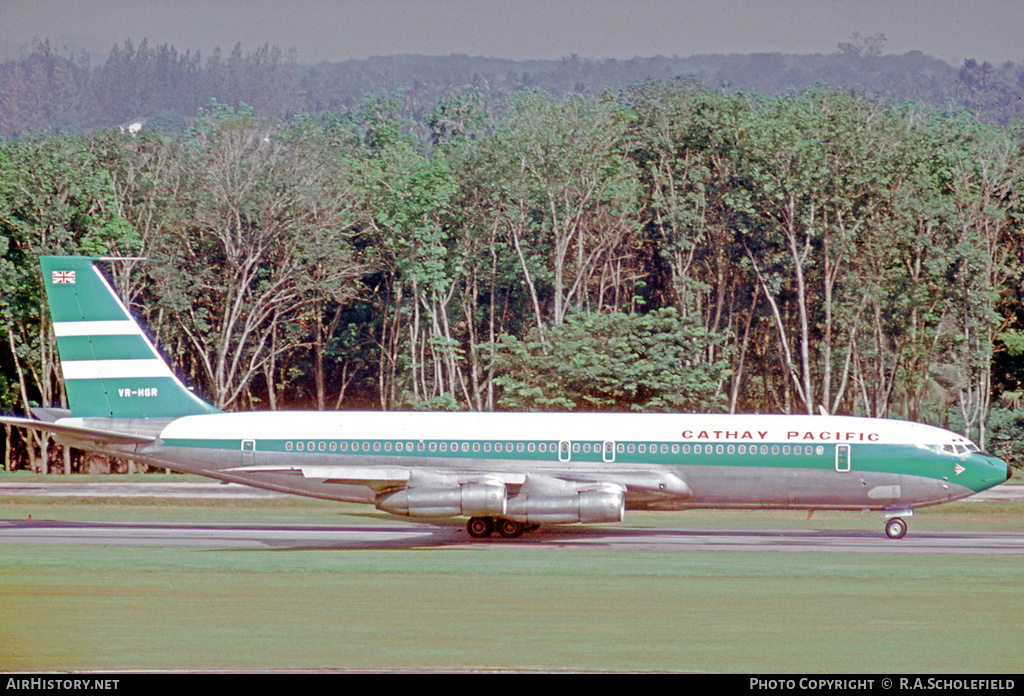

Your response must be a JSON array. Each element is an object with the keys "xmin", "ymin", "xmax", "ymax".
[{"xmin": 488, "ymin": 92, "xmax": 640, "ymax": 336}]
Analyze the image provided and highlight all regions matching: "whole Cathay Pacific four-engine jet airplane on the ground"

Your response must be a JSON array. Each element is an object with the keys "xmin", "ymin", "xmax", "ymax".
[{"xmin": 0, "ymin": 256, "xmax": 1013, "ymax": 538}]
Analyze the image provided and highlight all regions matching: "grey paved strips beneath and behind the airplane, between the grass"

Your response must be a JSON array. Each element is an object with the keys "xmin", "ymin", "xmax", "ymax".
[{"xmin": 0, "ymin": 483, "xmax": 1024, "ymax": 556}]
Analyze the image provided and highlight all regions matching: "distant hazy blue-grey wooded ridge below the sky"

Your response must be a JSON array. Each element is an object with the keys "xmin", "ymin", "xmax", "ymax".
[{"xmin": 6, "ymin": 34, "xmax": 1024, "ymax": 140}]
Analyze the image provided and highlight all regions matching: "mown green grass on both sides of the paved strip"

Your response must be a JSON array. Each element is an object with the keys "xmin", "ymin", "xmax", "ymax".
[{"xmin": 0, "ymin": 481, "xmax": 1024, "ymax": 673}]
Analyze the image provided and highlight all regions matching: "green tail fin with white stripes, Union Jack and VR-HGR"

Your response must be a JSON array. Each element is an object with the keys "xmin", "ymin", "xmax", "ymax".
[{"xmin": 39, "ymin": 256, "xmax": 218, "ymax": 418}]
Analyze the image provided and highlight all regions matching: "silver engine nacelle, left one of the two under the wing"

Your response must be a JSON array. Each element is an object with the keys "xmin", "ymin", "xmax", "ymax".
[{"xmin": 377, "ymin": 483, "xmax": 508, "ymax": 517}]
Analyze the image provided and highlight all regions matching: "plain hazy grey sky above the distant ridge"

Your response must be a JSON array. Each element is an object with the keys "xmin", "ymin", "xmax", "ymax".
[{"xmin": 0, "ymin": 0, "xmax": 1024, "ymax": 64}]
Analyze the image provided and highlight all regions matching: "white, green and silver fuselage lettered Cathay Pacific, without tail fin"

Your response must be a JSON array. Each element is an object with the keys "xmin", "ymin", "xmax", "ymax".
[{"xmin": 61, "ymin": 411, "xmax": 1008, "ymax": 514}]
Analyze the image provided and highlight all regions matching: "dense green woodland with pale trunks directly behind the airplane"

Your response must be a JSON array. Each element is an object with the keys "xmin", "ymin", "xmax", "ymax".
[{"xmin": 0, "ymin": 44, "xmax": 1024, "ymax": 472}]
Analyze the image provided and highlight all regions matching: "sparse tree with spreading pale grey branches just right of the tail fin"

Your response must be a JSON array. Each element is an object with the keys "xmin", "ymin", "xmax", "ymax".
[{"xmin": 150, "ymin": 107, "xmax": 362, "ymax": 407}]
